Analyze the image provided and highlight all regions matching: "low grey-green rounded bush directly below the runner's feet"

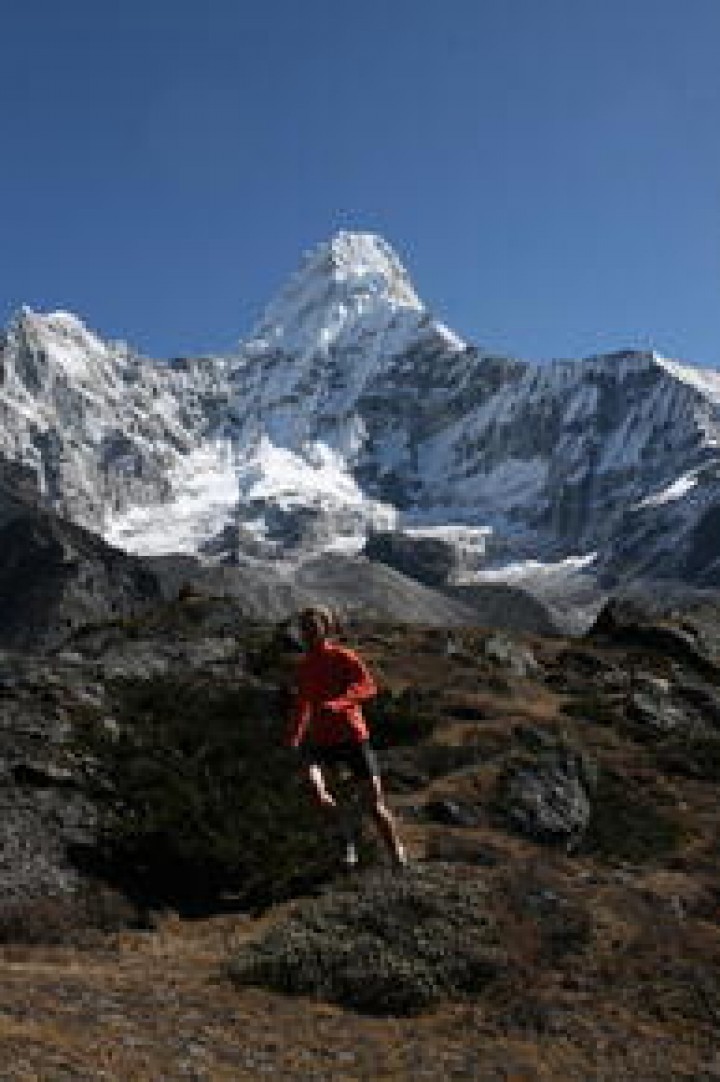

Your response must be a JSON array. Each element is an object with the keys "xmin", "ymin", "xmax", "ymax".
[{"xmin": 230, "ymin": 865, "xmax": 505, "ymax": 1015}]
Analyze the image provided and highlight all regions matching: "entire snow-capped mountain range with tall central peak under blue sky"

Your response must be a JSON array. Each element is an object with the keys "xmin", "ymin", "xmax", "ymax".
[{"xmin": 0, "ymin": 233, "xmax": 720, "ymax": 597}]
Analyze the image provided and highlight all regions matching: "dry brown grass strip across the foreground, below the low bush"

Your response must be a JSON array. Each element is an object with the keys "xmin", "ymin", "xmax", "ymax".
[{"xmin": 0, "ymin": 904, "xmax": 714, "ymax": 1082}]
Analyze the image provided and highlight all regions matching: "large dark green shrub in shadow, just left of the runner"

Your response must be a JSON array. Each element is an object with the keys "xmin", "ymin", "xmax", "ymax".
[{"xmin": 78, "ymin": 676, "xmax": 348, "ymax": 909}]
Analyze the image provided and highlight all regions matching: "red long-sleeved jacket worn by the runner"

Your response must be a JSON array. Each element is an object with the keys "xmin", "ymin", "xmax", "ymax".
[{"xmin": 286, "ymin": 642, "xmax": 378, "ymax": 748}]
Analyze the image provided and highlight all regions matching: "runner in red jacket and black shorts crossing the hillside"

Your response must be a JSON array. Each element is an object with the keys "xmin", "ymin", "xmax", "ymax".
[{"xmin": 286, "ymin": 606, "xmax": 407, "ymax": 866}]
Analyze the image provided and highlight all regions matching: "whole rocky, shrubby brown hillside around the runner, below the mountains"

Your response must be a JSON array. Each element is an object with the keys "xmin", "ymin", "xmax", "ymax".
[{"xmin": 0, "ymin": 597, "xmax": 720, "ymax": 1082}]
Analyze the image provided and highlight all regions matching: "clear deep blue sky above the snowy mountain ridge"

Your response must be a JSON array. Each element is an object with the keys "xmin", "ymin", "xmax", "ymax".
[{"xmin": 0, "ymin": 0, "xmax": 720, "ymax": 366}]
